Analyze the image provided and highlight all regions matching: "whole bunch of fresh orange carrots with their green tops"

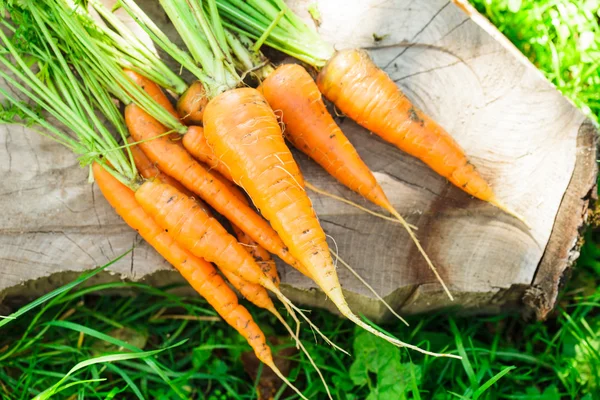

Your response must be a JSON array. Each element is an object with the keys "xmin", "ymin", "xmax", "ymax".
[{"xmin": 0, "ymin": 0, "xmax": 528, "ymax": 398}]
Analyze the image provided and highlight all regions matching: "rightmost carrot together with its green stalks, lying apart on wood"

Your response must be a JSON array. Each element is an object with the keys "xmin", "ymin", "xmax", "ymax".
[{"xmin": 215, "ymin": 0, "xmax": 524, "ymax": 222}]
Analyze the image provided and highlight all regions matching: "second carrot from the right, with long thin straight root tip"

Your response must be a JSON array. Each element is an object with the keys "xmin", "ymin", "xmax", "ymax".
[{"xmin": 260, "ymin": 64, "xmax": 453, "ymax": 299}]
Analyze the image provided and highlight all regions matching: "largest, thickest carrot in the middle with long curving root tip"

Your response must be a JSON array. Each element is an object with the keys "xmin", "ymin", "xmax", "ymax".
[{"xmin": 204, "ymin": 88, "xmax": 458, "ymax": 356}]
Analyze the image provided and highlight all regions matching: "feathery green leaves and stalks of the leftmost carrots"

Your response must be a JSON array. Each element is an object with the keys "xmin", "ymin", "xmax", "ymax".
[{"xmin": 0, "ymin": 2, "xmax": 137, "ymax": 185}]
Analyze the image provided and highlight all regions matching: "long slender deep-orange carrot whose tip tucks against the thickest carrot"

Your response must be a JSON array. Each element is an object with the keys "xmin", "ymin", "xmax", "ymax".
[{"xmin": 125, "ymin": 104, "xmax": 297, "ymax": 274}]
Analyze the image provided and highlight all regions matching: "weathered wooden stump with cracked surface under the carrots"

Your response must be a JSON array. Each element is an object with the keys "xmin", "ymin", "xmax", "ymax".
[{"xmin": 0, "ymin": 0, "xmax": 597, "ymax": 319}]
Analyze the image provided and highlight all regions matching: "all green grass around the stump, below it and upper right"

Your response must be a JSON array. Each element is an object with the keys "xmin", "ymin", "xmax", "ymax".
[{"xmin": 0, "ymin": 0, "xmax": 600, "ymax": 400}]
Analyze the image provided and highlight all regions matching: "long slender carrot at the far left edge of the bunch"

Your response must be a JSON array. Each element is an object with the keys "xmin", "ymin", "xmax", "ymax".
[{"xmin": 92, "ymin": 163, "xmax": 305, "ymax": 398}]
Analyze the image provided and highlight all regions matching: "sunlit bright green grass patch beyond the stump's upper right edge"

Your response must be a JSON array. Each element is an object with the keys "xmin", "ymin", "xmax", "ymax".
[{"xmin": 471, "ymin": 0, "xmax": 600, "ymax": 122}]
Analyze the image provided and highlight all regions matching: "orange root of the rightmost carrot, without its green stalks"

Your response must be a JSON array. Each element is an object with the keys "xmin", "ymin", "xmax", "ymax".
[{"xmin": 317, "ymin": 49, "xmax": 506, "ymax": 214}]
